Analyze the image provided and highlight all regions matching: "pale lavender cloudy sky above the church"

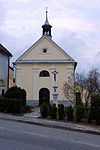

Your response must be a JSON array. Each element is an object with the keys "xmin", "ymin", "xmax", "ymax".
[{"xmin": 0, "ymin": 0, "xmax": 100, "ymax": 72}]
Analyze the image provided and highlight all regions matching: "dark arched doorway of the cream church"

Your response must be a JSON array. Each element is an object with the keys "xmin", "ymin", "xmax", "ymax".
[{"xmin": 39, "ymin": 88, "xmax": 50, "ymax": 105}]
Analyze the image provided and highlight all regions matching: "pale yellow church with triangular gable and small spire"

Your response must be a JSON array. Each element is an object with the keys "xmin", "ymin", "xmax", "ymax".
[{"xmin": 14, "ymin": 12, "xmax": 76, "ymax": 105}]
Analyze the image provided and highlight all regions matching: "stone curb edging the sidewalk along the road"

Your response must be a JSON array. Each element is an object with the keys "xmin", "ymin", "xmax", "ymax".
[{"xmin": 0, "ymin": 116, "xmax": 100, "ymax": 135}]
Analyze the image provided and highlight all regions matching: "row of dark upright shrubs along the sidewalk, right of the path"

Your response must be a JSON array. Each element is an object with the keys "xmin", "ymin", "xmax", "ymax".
[{"xmin": 39, "ymin": 100, "xmax": 100, "ymax": 125}]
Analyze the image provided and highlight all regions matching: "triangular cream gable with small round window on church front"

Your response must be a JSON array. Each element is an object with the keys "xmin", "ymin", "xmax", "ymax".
[{"xmin": 17, "ymin": 35, "xmax": 73, "ymax": 61}]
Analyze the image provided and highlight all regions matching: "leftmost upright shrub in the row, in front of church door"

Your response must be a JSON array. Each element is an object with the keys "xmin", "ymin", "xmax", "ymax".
[{"xmin": 40, "ymin": 103, "xmax": 48, "ymax": 118}]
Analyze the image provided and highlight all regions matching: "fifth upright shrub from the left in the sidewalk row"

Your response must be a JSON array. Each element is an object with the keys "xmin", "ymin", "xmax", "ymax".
[{"xmin": 75, "ymin": 105, "xmax": 84, "ymax": 122}]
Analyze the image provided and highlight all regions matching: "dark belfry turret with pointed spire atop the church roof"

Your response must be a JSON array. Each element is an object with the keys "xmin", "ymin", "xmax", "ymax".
[{"xmin": 42, "ymin": 7, "xmax": 52, "ymax": 37}]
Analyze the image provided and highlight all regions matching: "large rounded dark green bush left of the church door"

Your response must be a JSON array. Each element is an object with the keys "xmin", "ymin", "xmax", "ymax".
[{"xmin": 4, "ymin": 86, "xmax": 26, "ymax": 106}]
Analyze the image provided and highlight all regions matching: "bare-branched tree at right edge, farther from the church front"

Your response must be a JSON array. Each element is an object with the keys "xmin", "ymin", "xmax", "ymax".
[{"xmin": 76, "ymin": 68, "xmax": 100, "ymax": 105}]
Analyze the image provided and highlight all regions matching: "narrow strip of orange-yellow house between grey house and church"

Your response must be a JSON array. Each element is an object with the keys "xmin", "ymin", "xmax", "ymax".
[{"xmin": 9, "ymin": 67, "xmax": 14, "ymax": 88}]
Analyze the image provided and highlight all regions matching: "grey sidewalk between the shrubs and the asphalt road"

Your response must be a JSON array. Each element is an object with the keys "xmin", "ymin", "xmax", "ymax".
[{"xmin": 0, "ymin": 113, "xmax": 100, "ymax": 135}]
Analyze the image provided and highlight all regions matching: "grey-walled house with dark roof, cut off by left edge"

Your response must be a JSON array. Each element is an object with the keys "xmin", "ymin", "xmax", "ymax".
[{"xmin": 0, "ymin": 44, "xmax": 12, "ymax": 96}]
